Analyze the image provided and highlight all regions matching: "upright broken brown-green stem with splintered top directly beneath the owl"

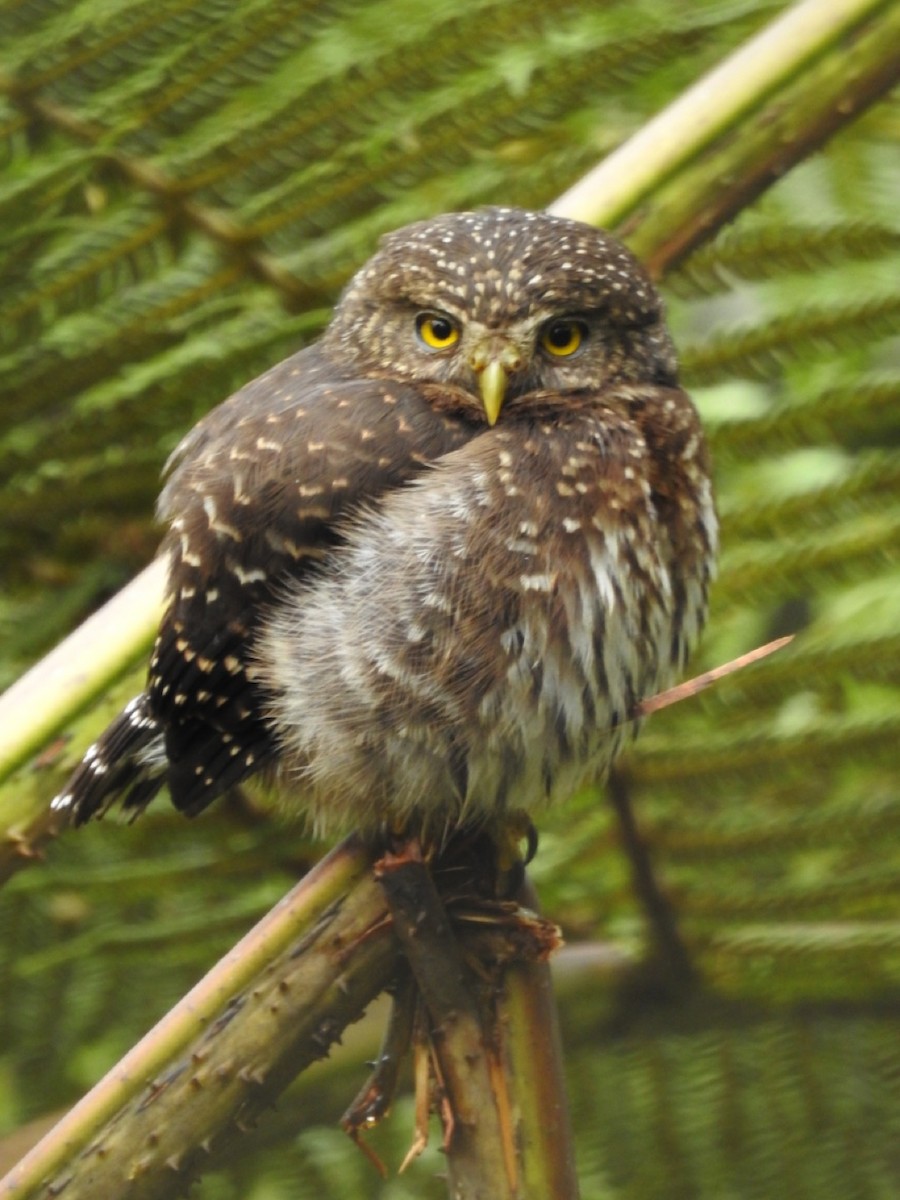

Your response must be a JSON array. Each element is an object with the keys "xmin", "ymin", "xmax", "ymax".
[{"xmin": 378, "ymin": 857, "xmax": 578, "ymax": 1200}]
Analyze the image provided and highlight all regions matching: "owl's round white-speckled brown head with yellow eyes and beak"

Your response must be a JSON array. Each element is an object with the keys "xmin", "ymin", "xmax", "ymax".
[{"xmin": 324, "ymin": 208, "xmax": 677, "ymax": 425}]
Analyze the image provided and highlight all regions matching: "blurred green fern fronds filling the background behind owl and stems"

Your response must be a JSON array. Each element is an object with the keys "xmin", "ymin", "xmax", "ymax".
[{"xmin": 0, "ymin": 0, "xmax": 900, "ymax": 1200}]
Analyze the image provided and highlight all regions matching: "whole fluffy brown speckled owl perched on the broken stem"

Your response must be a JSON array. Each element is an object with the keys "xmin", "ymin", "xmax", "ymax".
[{"xmin": 53, "ymin": 208, "xmax": 716, "ymax": 833}]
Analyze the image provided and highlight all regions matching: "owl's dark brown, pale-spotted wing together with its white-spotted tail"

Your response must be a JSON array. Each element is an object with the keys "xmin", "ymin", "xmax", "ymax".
[{"xmin": 54, "ymin": 346, "xmax": 472, "ymax": 822}]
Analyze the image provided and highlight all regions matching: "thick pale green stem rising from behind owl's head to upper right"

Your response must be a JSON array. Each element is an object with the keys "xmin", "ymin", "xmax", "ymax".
[{"xmin": 551, "ymin": 0, "xmax": 900, "ymax": 264}]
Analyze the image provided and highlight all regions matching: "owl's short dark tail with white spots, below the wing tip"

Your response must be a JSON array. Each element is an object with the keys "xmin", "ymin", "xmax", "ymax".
[{"xmin": 50, "ymin": 692, "xmax": 168, "ymax": 826}]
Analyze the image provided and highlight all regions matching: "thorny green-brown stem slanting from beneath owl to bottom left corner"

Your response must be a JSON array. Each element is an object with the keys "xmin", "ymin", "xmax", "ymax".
[{"xmin": 0, "ymin": 840, "xmax": 388, "ymax": 1200}]
